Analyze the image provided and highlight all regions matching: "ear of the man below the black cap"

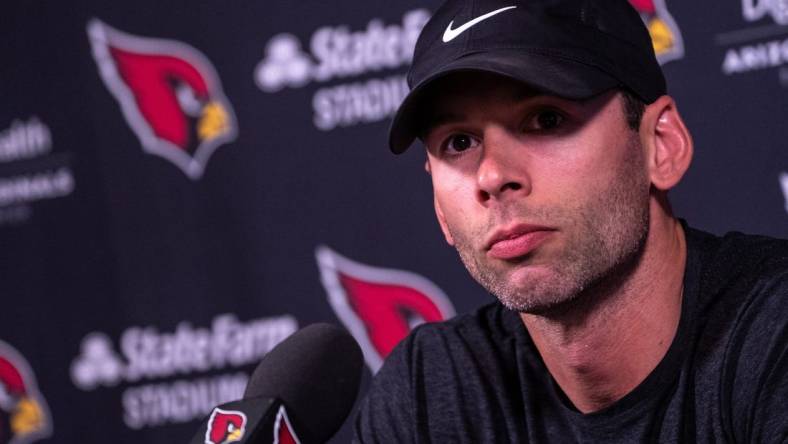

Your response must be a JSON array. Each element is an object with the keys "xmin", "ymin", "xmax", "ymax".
[{"xmin": 640, "ymin": 96, "xmax": 693, "ymax": 191}]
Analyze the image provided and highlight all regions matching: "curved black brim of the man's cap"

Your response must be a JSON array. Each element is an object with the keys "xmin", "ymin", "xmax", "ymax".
[{"xmin": 389, "ymin": 50, "xmax": 620, "ymax": 154}]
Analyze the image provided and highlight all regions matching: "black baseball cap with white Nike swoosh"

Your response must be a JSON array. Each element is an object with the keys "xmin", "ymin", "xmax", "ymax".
[{"xmin": 389, "ymin": 0, "xmax": 667, "ymax": 154}]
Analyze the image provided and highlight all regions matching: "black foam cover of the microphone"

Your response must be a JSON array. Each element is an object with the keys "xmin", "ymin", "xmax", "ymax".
[{"xmin": 244, "ymin": 323, "xmax": 364, "ymax": 444}]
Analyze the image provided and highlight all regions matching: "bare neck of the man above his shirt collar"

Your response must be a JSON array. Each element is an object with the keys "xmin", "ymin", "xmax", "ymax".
[{"xmin": 520, "ymin": 218, "xmax": 687, "ymax": 413}]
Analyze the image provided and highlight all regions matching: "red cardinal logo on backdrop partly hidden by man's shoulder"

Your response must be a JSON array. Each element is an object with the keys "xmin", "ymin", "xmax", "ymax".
[{"xmin": 316, "ymin": 246, "xmax": 454, "ymax": 373}]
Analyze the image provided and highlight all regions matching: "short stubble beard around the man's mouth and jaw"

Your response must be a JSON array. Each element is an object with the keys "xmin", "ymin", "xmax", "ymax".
[{"xmin": 449, "ymin": 137, "xmax": 649, "ymax": 314}]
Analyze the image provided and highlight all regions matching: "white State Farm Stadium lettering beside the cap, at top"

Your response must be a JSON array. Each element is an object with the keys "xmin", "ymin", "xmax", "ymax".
[{"xmin": 254, "ymin": 9, "xmax": 430, "ymax": 131}]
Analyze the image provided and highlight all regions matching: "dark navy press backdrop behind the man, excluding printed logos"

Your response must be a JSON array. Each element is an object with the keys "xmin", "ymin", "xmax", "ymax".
[{"xmin": 0, "ymin": 0, "xmax": 788, "ymax": 443}]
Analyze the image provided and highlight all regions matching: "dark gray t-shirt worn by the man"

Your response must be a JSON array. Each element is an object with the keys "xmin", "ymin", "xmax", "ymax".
[{"xmin": 355, "ymin": 228, "xmax": 788, "ymax": 443}]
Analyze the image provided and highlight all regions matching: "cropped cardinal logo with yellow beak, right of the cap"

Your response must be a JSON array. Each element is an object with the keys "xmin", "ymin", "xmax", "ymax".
[{"xmin": 629, "ymin": 0, "xmax": 684, "ymax": 64}]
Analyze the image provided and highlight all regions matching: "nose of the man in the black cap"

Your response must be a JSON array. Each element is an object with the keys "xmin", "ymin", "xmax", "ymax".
[{"xmin": 476, "ymin": 127, "xmax": 531, "ymax": 204}]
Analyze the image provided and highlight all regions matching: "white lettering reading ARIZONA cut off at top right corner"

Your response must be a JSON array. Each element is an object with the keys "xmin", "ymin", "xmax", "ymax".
[{"xmin": 715, "ymin": 0, "xmax": 788, "ymax": 83}]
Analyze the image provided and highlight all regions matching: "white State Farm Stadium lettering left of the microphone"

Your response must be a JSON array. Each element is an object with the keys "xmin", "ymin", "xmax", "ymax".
[{"xmin": 71, "ymin": 314, "xmax": 298, "ymax": 429}]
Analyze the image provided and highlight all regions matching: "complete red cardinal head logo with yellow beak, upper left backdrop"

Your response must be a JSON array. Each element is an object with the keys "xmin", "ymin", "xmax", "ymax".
[{"xmin": 88, "ymin": 19, "xmax": 237, "ymax": 180}]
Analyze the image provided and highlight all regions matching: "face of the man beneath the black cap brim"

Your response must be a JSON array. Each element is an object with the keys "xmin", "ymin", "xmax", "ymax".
[{"xmin": 423, "ymin": 74, "xmax": 650, "ymax": 313}]
